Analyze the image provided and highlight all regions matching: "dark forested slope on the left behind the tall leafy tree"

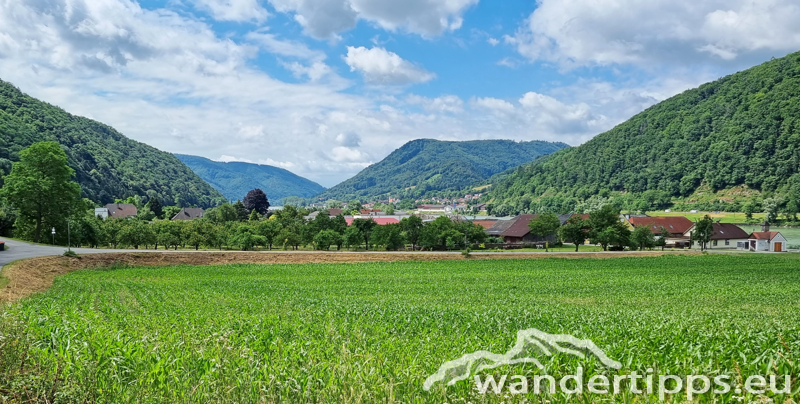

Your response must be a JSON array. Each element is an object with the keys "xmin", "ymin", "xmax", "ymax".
[{"xmin": 0, "ymin": 80, "xmax": 224, "ymax": 206}]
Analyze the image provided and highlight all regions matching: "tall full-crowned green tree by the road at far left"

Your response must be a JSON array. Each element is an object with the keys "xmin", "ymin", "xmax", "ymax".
[{"xmin": 0, "ymin": 142, "xmax": 81, "ymax": 242}]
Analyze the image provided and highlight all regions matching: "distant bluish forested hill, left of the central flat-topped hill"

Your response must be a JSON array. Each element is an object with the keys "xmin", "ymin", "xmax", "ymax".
[{"xmin": 175, "ymin": 154, "xmax": 325, "ymax": 205}]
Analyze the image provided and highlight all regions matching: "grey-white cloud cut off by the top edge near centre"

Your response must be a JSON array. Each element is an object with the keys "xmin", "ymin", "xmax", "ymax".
[{"xmin": 270, "ymin": 0, "xmax": 478, "ymax": 39}]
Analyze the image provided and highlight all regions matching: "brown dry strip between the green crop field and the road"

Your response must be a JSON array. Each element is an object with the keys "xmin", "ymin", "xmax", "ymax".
[{"xmin": 0, "ymin": 251, "xmax": 693, "ymax": 302}]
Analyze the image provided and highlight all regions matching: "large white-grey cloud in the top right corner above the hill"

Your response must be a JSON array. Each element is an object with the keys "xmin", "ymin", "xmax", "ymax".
[{"xmin": 505, "ymin": 0, "xmax": 800, "ymax": 67}]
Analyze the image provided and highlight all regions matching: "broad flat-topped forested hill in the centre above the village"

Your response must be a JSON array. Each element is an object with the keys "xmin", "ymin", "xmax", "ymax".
[{"xmin": 319, "ymin": 139, "xmax": 569, "ymax": 201}]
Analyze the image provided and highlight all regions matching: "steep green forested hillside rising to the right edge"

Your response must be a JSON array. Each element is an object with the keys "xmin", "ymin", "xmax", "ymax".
[{"xmin": 489, "ymin": 52, "xmax": 800, "ymax": 213}]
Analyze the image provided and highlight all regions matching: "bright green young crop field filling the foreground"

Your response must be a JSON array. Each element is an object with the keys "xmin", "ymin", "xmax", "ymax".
[{"xmin": 0, "ymin": 254, "xmax": 800, "ymax": 403}]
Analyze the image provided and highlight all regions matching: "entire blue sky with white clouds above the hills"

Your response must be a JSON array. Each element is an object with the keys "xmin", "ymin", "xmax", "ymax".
[{"xmin": 0, "ymin": 0, "xmax": 800, "ymax": 187}]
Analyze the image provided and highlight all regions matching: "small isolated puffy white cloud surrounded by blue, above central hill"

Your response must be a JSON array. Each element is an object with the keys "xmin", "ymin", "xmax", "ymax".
[{"xmin": 344, "ymin": 46, "xmax": 436, "ymax": 85}]
